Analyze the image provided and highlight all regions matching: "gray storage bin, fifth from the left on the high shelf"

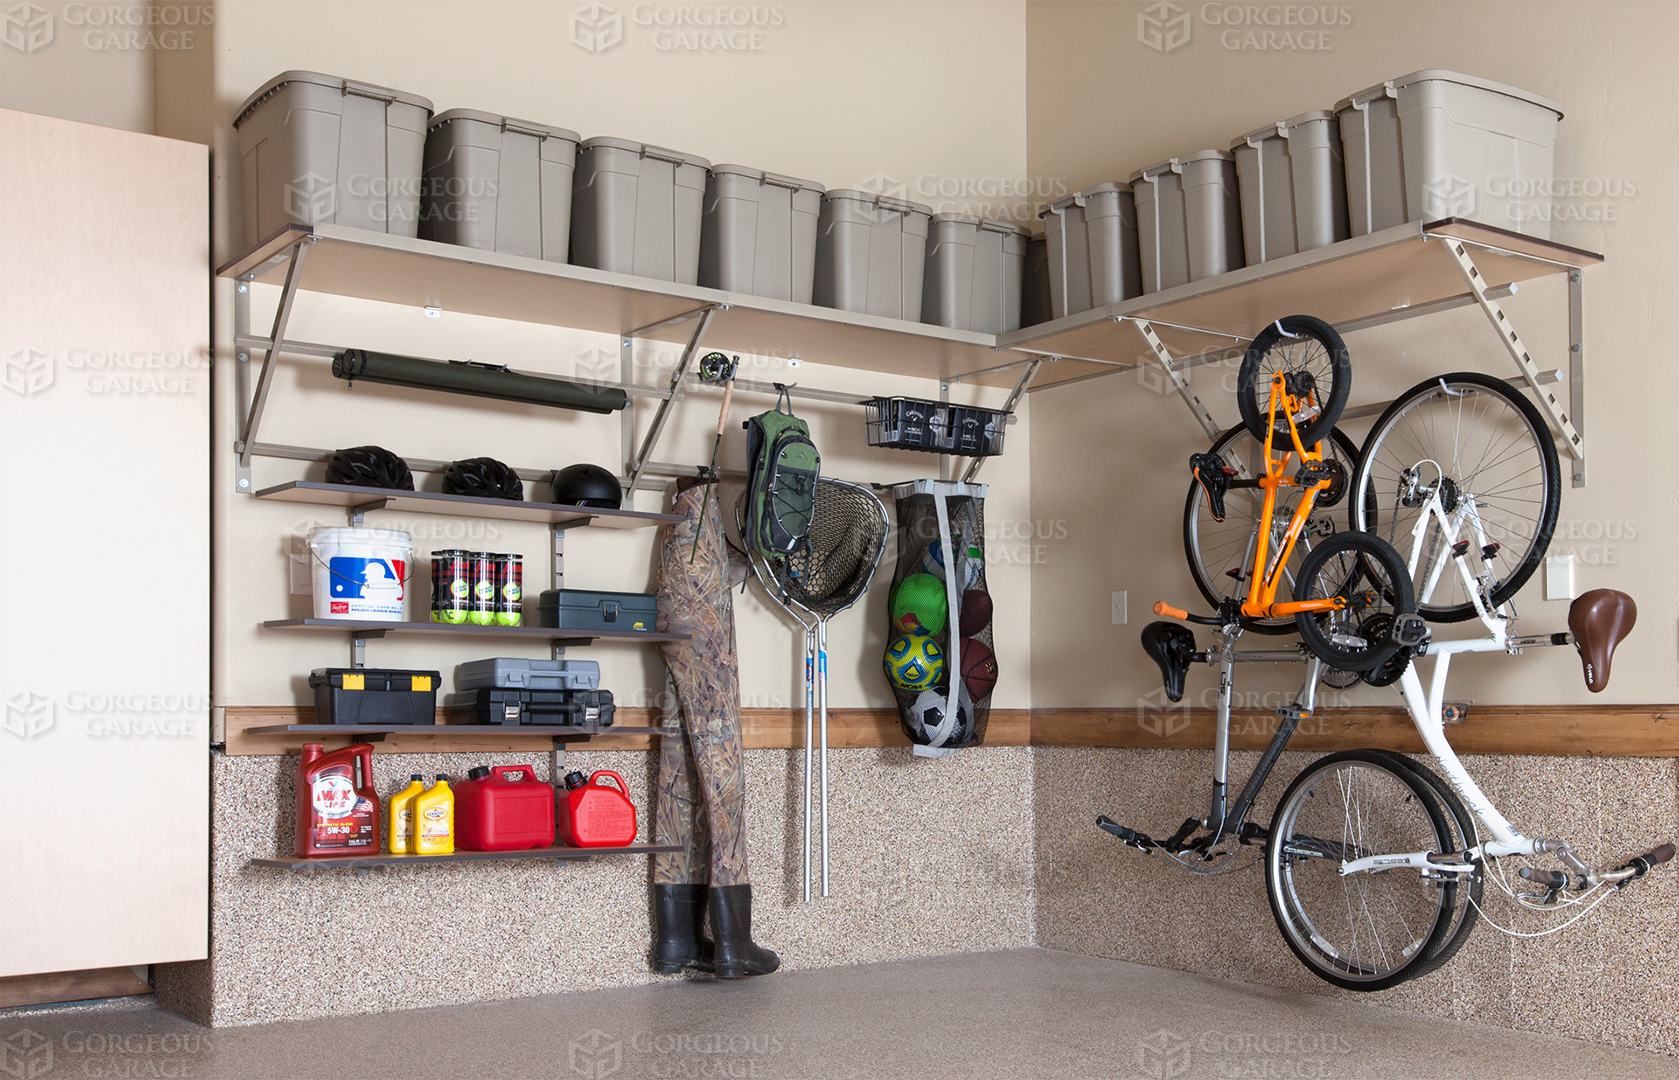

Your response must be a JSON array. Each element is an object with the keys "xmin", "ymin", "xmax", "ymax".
[{"xmin": 811, "ymin": 188, "xmax": 934, "ymax": 321}]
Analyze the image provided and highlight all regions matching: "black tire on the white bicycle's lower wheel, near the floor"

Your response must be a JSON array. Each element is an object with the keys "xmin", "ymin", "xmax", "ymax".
[{"xmin": 1264, "ymin": 749, "xmax": 1451, "ymax": 991}]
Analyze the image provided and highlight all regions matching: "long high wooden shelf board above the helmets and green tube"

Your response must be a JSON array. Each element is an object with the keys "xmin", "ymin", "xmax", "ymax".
[{"xmin": 217, "ymin": 225, "xmax": 1017, "ymax": 385}]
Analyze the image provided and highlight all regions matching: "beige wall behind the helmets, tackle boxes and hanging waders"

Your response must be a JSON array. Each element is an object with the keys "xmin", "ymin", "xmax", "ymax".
[{"xmin": 196, "ymin": 3, "xmax": 1033, "ymax": 718}]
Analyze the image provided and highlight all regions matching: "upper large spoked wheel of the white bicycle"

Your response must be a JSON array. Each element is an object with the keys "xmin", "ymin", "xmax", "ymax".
[{"xmin": 1348, "ymin": 371, "xmax": 1561, "ymax": 623}]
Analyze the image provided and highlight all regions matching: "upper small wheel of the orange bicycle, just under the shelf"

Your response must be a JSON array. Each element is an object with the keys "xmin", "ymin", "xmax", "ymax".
[{"xmin": 1236, "ymin": 316, "xmax": 1353, "ymax": 447}]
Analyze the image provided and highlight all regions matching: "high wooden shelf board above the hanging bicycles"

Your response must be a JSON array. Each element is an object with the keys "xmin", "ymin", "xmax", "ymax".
[{"xmin": 997, "ymin": 218, "xmax": 1602, "ymax": 390}]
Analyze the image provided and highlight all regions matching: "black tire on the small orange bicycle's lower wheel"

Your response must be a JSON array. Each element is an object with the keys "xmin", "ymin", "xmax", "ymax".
[{"xmin": 1295, "ymin": 532, "xmax": 1417, "ymax": 674}]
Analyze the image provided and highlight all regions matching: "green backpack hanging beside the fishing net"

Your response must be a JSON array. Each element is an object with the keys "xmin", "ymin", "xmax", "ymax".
[{"xmin": 745, "ymin": 383, "xmax": 823, "ymax": 559}]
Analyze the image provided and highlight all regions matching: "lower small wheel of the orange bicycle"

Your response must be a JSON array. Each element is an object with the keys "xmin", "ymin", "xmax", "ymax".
[{"xmin": 1295, "ymin": 532, "xmax": 1415, "ymax": 679}]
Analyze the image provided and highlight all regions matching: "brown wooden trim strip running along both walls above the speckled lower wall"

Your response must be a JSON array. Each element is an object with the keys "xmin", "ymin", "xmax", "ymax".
[{"xmin": 225, "ymin": 705, "xmax": 1679, "ymax": 758}]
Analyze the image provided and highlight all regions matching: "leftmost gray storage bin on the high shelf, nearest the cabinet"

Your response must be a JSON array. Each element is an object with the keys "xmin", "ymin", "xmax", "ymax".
[{"xmin": 233, "ymin": 71, "xmax": 432, "ymax": 249}]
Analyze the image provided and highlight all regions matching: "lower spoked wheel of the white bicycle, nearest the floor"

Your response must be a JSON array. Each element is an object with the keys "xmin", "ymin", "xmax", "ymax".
[{"xmin": 1266, "ymin": 751, "xmax": 1452, "ymax": 991}]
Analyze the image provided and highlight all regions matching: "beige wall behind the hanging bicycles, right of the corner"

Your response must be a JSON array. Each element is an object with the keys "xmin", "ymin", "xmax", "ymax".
[{"xmin": 1028, "ymin": 3, "xmax": 1679, "ymax": 708}]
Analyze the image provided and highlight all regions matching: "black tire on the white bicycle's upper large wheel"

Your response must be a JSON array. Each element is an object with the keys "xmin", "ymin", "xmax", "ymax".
[{"xmin": 1347, "ymin": 371, "xmax": 1561, "ymax": 623}]
